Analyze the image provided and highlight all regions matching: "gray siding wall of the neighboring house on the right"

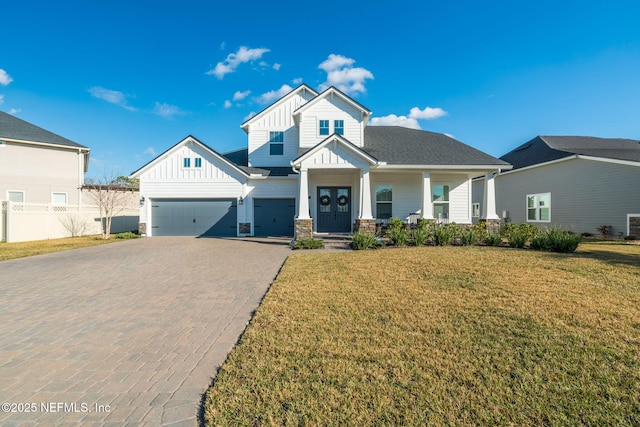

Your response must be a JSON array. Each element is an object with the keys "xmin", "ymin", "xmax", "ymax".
[{"xmin": 496, "ymin": 158, "xmax": 640, "ymax": 235}]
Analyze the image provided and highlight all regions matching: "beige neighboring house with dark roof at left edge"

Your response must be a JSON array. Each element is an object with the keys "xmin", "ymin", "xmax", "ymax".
[{"xmin": 0, "ymin": 111, "xmax": 89, "ymax": 205}]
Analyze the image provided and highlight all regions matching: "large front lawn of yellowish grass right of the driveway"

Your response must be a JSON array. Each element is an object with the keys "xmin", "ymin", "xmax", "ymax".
[{"xmin": 205, "ymin": 243, "xmax": 640, "ymax": 426}]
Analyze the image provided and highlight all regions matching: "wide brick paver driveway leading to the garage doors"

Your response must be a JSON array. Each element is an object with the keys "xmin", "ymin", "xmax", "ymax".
[{"xmin": 0, "ymin": 237, "xmax": 289, "ymax": 426}]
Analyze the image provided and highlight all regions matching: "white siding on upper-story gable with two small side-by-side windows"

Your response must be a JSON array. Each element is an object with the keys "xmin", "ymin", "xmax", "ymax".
[{"xmin": 300, "ymin": 96, "xmax": 364, "ymax": 148}]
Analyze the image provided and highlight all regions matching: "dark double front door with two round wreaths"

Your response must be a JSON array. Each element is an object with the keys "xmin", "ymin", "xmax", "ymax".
[{"xmin": 318, "ymin": 187, "xmax": 351, "ymax": 233}]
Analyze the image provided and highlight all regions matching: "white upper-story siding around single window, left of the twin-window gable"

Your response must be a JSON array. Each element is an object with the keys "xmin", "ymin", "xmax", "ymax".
[{"xmin": 247, "ymin": 91, "xmax": 313, "ymax": 167}]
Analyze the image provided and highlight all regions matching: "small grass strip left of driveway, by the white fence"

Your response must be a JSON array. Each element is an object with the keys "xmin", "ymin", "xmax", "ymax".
[{"xmin": 0, "ymin": 236, "xmax": 121, "ymax": 261}]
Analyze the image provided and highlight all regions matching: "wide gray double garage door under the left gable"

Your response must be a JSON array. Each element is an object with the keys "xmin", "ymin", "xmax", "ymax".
[{"xmin": 151, "ymin": 199, "xmax": 238, "ymax": 237}]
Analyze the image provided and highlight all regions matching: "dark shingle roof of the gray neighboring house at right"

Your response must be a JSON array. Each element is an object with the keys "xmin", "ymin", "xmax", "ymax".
[{"xmin": 500, "ymin": 136, "xmax": 640, "ymax": 169}]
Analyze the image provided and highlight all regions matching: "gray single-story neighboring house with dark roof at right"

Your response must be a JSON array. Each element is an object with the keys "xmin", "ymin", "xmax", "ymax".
[{"xmin": 474, "ymin": 136, "xmax": 640, "ymax": 236}]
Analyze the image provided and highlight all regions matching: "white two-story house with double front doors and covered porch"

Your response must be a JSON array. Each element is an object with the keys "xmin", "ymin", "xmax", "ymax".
[{"xmin": 132, "ymin": 84, "xmax": 510, "ymax": 238}]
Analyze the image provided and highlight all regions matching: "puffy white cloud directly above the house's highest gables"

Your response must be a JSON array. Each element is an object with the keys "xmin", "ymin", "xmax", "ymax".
[{"xmin": 318, "ymin": 53, "xmax": 373, "ymax": 95}]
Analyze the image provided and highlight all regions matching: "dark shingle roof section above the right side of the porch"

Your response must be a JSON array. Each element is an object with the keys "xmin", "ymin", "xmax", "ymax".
[{"xmin": 363, "ymin": 126, "xmax": 511, "ymax": 169}]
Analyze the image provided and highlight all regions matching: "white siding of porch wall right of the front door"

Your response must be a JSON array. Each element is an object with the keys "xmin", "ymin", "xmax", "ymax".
[{"xmin": 371, "ymin": 172, "xmax": 471, "ymax": 224}]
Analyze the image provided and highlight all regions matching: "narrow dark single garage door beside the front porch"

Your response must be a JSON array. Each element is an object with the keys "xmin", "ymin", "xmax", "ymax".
[{"xmin": 253, "ymin": 199, "xmax": 296, "ymax": 236}]
